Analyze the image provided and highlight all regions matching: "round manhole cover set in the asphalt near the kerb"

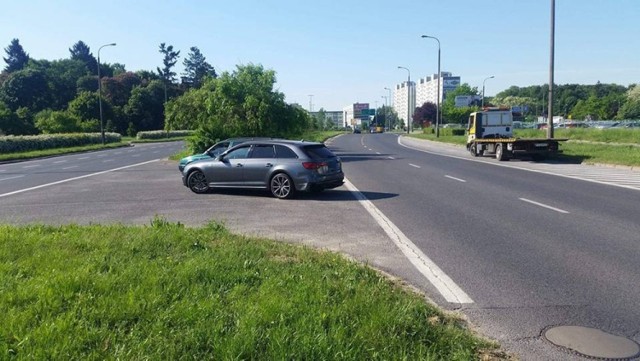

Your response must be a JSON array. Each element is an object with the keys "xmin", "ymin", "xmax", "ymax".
[{"xmin": 544, "ymin": 326, "xmax": 640, "ymax": 360}]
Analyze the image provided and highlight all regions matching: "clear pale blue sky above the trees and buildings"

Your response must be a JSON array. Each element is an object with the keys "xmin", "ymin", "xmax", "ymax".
[{"xmin": 0, "ymin": 0, "xmax": 640, "ymax": 110}]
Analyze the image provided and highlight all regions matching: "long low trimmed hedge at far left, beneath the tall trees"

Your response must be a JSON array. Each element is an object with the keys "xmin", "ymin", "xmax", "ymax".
[{"xmin": 0, "ymin": 133, "xmax": 122, "ymax": 153}]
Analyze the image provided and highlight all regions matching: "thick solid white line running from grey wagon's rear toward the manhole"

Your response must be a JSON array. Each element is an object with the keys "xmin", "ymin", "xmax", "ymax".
[{"xmin": 344, "ymin": 178, "xmax": 473, "ymax": 304}]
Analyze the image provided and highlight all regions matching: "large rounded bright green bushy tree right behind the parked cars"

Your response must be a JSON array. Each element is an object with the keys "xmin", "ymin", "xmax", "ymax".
[{"xmin": 165, "ymin": 64, "xmax": 312, "ymax": 152}]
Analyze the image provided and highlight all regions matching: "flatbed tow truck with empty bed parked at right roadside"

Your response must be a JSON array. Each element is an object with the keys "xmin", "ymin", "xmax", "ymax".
[{"xmin": 467, "ymin": 107, "xmax": 566, "ymax": 161}]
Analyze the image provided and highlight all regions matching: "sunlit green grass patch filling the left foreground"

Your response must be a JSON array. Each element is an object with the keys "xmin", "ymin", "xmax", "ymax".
[{"xmin": 0, "ymin": 219, "xmax": 496, "ymax": 360}]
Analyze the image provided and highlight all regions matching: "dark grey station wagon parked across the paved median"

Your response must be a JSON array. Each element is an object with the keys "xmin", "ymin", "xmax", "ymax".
[{"xmin": 182, "ymin": 140, "xmax": 344, "ymax": 198}]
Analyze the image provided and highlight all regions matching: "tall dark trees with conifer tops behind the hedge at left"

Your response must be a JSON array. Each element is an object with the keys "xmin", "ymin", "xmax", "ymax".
[{"xmin": 0, "ymin": 39, "xmax": 217, "ymax": 135}]
